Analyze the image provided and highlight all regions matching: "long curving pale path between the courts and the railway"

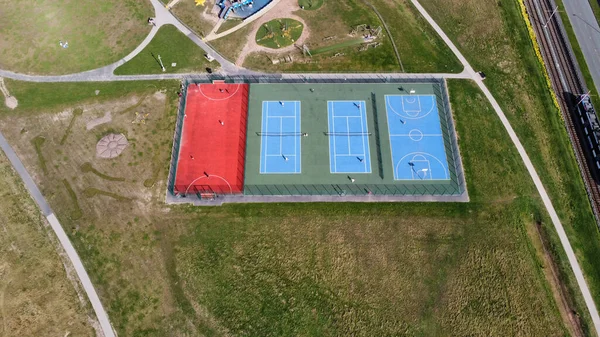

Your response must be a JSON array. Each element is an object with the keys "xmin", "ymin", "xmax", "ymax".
[{"xmin": 411, "ymin": 0, "xmax": 600, "ymax": 336}]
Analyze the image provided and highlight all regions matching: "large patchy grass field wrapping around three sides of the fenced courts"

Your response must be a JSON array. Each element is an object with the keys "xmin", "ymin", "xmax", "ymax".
[{"xmin": 0, "ymin": 81, "xmax": 576, "ymax": 336}]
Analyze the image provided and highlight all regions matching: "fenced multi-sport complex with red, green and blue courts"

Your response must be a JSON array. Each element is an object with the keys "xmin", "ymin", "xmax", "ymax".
[{"xmin": 167, "ymin": 78, "xmax": 468, "ymax": 204}]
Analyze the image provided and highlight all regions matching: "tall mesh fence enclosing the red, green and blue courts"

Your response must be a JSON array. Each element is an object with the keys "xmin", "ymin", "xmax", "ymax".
[{"xmin": 168, "ymin": 74, "xmax": 466, "ymax": 199}]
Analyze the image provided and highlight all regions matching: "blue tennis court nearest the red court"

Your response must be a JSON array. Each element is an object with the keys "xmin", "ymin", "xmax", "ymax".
[{"xmin": 260, "ymin": 101, "xmax": 302, "ymax": 174}]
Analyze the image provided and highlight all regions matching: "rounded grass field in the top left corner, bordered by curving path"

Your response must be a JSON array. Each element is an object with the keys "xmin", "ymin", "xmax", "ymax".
[{"xmin": 0, "ymin": 0, "xmax": 154, "ymax": 74}]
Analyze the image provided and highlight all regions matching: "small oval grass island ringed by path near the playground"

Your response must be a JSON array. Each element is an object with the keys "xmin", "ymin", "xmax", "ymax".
[{"xmin": 256, "ymin": 18, "xmax": 304, "ymax": 49}]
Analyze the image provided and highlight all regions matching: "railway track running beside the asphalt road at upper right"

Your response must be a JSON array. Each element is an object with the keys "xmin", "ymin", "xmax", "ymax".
[{"xmin": 524, "ymin": 0, "xmax": 600, "ymax": 227}]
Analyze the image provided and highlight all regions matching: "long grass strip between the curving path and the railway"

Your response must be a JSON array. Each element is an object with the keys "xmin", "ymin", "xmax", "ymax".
[{"xmin": 422, "ymin": 0, "xmax": 600, "ymax": 331}]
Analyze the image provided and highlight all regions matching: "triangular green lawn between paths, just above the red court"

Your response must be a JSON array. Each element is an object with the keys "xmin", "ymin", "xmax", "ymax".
[{"xmin": 115, "ymin": 25, "xmax": 213, "ymax": 75}]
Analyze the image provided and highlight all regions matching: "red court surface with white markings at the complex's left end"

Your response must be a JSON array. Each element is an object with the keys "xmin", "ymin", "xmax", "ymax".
[{"xmin": 175, "ymin": 83, "xmax": 248, "ymax": 194}]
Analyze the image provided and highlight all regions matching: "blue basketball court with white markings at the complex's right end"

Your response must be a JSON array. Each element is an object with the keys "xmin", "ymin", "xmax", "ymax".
[{"xmin": 385, "ymin": 95, "xmax": 450, "ymax": 180}]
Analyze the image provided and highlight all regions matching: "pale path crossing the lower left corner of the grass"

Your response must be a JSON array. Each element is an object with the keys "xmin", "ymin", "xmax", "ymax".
[{"xmin": 0, "ymin": 132, "xmax": 116, "ymax": 337}]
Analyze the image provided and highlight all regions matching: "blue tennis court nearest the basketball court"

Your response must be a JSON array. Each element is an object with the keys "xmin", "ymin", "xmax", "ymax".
[{"xmin": 327, "ymin": 101, "xmax": 371, "ymax": 173}]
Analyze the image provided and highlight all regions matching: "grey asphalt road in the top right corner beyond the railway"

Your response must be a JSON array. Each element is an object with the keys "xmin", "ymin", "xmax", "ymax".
[{"xmin": 563, "ymin": 0, "xmax": 600, "ymax": 94}]
